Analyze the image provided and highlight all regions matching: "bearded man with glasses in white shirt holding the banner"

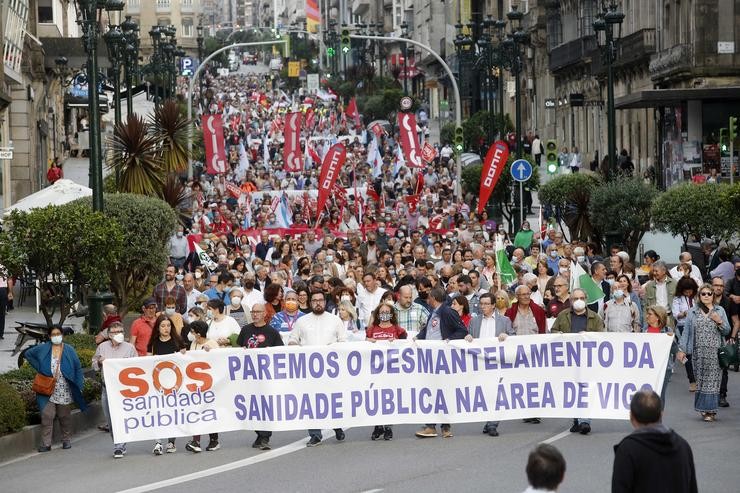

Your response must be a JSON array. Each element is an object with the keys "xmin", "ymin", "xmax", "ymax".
[{"xmin": 288, "ymin": 291, "xmax": 347, "ymax": 447}]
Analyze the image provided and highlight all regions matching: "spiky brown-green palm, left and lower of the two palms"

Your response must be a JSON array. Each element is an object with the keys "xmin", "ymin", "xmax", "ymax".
[{"xmin": 106, "ymin": 114, "xmax": 165, "ymax": 197}]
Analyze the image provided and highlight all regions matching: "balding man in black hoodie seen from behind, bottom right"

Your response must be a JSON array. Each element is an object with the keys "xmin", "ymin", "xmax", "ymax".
[{"xmin": 612, "ymin": 390, "xmax": 697, "ymax": 493}]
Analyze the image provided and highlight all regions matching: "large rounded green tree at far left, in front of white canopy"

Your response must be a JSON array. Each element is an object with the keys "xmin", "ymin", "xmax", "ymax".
[{"xmin": 0, "ymin": 202, "xmax": 123, "ymax": 325}]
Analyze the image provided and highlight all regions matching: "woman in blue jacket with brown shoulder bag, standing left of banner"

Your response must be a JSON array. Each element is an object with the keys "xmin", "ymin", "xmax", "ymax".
[{"xmin": 25, "ymin": 325, "xmax": 87, "ymax": 452}]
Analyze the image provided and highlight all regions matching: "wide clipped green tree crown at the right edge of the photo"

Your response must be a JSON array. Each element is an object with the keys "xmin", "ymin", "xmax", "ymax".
[{"xmin": 652, "ymin": 183, "xmax": 740, "ymax": 245}]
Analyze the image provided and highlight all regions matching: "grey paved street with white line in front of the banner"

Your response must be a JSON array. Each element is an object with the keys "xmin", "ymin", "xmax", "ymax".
[{"xmin": 0, "ymin": 368, "xmax": 740, "ymax": 493}]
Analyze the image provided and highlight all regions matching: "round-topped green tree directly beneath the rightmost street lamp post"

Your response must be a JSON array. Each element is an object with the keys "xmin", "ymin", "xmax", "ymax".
[{"xmin": 588, "ymin": 178, "xmax": 658, "ymax": 258}]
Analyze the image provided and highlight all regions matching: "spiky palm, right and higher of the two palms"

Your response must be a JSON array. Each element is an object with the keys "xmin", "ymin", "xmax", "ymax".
[{"xmin": 149, "ymin": 99, "xmax": 190, "ymax": 173}]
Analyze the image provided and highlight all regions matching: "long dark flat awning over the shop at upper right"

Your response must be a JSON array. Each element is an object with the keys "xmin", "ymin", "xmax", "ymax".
[{"xmin": 614, "ymin": 87, "xmax": 740, "ymax": 110}]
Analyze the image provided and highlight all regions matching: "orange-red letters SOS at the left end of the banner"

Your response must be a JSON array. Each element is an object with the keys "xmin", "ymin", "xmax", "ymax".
[{"xmin": 118, "ymin": 361, "xmax": 213, "ymax": 398}]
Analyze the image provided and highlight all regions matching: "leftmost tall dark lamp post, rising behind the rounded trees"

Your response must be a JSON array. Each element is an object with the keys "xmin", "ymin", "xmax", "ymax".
[{"xmin": 74, "ymin": 0, "xmax": 124, "ymax": 211}]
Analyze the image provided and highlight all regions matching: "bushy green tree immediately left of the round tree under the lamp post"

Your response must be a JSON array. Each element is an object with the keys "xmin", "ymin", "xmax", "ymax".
[{"xmin": 539, "ymin": 173, "xmax": 601, "ymax": 243}]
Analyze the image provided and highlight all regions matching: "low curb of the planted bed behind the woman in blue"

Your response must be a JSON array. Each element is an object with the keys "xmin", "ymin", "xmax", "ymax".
[{"xmin": 0, "ymin": 402, "xmax": 104, "ymax": 465}]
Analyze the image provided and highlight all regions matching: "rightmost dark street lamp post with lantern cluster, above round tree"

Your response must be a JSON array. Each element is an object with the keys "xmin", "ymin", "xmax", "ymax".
[{"xmin": 593, "ymin": 1, "xmax": 624, "ymax": 177}]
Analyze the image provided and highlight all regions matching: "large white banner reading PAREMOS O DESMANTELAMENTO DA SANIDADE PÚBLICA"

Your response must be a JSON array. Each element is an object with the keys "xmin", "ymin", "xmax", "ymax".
[{"xmin": 104, "ymin": 333, "xmax": 671, "ymax": 442}]
